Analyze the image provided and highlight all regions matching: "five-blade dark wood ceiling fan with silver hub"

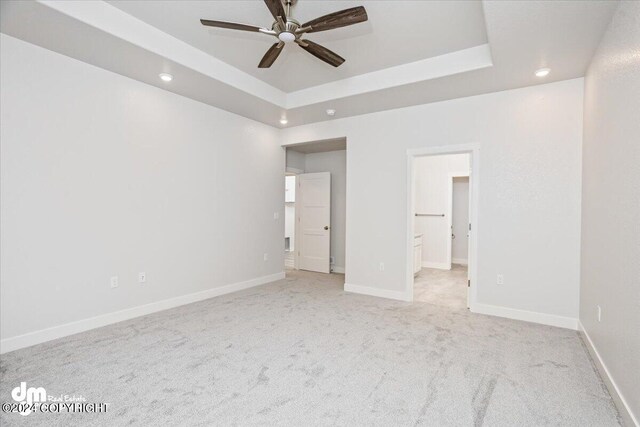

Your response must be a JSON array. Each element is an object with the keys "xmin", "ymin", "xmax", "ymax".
[{"xmin": 200, "ymin": 0, "xmax": 368, "ymax": 68}]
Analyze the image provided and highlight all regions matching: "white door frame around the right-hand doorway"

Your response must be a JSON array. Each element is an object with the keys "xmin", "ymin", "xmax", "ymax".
[{"xmin": 405, "ymin": 143, "xmax": 480, "ymax": 311}]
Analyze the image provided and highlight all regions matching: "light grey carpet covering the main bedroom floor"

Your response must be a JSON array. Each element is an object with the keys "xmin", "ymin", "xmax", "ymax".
[{"xmin": 0, "ymin": 272, "xmax": 619, "ymax": 427}]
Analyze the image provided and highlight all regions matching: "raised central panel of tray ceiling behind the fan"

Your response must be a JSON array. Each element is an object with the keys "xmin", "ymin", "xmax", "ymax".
[{"xmin": 109, "ymin": 0, "xmax": 487, "ymax": 92}]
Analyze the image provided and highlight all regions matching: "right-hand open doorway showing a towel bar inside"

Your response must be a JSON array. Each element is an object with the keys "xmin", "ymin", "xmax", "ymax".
[{"xmin": 408, "ymin": 145, "xmax": 475, "ymax": 309}]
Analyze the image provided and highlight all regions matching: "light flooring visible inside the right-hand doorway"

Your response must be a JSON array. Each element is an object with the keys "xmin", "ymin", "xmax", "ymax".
[{"xmin": 413, "ymin": 264, "xmax": 467, "ymax": 310}]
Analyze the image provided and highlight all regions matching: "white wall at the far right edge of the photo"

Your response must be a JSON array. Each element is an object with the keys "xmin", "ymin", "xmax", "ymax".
[{"xmin": 580, "ymin": 2, "xmax": 640, "ymax": 425}]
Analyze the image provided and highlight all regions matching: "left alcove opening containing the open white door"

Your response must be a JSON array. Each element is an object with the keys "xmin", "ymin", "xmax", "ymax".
[{"xmin": 285, "ymin": 138, "xmax": 347, "ymax": 273}]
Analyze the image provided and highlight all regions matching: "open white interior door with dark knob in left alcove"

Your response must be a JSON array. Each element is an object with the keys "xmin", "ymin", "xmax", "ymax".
[{"xmin": 296, "ymin": 172, "xmax": 331, "ymax": 273}]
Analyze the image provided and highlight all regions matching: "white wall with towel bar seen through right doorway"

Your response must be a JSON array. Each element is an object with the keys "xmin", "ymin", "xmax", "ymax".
[{"xmin": 414, "ymin": 154, "xmax": 470, "ymax": 269}]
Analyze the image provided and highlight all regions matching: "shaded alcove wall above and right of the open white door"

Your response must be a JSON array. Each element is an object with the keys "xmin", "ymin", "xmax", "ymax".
[{"xmin": 304, "ymin": 150, "xmax": 347, "ymax": 272}]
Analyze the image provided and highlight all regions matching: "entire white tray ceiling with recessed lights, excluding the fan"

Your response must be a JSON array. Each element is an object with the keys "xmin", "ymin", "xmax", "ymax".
[{"xmin": 0, "ymin": 0, "xmax": 617, "ymax": 127}]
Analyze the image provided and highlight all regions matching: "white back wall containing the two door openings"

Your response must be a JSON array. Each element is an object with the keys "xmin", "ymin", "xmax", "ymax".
[{"xmin": 283, "ymin": 79, "xmax": 583, "ymax": 327}]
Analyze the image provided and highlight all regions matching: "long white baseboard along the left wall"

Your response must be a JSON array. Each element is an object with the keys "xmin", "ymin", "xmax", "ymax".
[{"xmin": 0, "ymin": 271, "xmax": 285, "ymax": 354}]
